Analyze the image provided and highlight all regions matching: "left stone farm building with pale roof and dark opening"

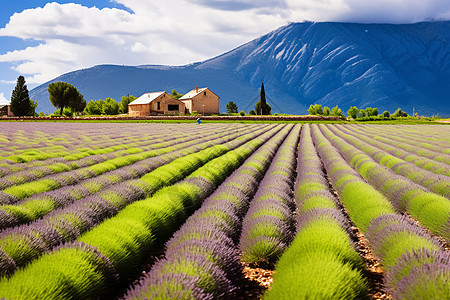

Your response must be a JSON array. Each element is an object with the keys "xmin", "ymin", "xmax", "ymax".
[{"xmin": 128, "ymin": 92, "xmax": 186, "ymax": 117}]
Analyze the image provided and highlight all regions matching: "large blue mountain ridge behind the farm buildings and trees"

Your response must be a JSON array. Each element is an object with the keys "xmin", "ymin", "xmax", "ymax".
[{"xmin": 30, "ymin": 21, "xmax": 450, "ymax": 116}]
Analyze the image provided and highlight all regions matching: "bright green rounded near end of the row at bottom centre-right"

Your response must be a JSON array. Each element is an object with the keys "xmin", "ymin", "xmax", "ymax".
[{"xmin": 264, "ymin": 208, "xmax": 369, "ymax": 299}]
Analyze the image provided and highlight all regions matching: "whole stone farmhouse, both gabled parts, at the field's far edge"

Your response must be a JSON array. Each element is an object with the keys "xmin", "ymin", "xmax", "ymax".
[{"xmin": 128, "ymin": 87, "xmax": 220, "ymax": 116}]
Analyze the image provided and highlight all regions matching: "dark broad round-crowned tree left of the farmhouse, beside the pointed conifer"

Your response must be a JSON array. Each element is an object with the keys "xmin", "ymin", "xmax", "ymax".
[{"xmin": 48, "ymin": 81, "xmax": 84, "ymax": 115}]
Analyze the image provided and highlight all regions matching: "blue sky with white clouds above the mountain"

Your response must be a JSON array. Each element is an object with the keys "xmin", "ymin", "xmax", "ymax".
[{"xmin": 0, "ymin": 0, "xmax": 450, "ymax": 106}]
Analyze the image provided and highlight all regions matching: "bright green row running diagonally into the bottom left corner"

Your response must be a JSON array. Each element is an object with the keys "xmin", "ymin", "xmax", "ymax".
[{"xmin": 0, "ymin": 125, "xmax": 288, "ymax": 298}]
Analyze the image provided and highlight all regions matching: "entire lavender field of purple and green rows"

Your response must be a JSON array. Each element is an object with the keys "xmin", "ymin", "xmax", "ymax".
[{"xmin": 0, "ymin": 123, "xmax": 450, "ymax": 299}]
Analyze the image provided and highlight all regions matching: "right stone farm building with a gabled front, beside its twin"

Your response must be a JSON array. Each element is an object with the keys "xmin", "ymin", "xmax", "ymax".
[{"xmin": 180, "ymin": 87, "xmax": 220, "ymax": 115}]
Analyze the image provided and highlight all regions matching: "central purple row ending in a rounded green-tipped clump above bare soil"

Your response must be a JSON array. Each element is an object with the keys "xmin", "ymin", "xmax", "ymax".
[{"xmin": 239, "ymin": 125, "xmax": 301, "ymax": 264}]
